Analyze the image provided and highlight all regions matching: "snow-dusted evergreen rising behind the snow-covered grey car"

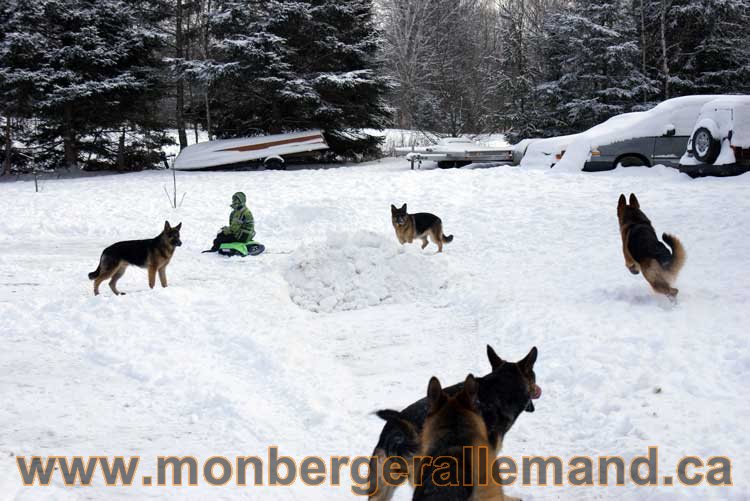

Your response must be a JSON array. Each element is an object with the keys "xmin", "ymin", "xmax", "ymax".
[{"xmin": 537, "ymin": 0, "xmax": 657, "ymax": 135}]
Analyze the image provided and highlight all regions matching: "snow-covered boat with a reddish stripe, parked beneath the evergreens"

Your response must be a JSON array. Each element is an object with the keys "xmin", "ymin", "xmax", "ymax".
[{"xmin": 174, "ymin": 130, "xmax": 328, "ymax": 170}]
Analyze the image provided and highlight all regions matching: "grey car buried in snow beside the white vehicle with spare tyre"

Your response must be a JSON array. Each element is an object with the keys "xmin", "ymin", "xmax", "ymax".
[{"xmin": 548, "ymin": 95, "xmax": 721, "ymax": 172}]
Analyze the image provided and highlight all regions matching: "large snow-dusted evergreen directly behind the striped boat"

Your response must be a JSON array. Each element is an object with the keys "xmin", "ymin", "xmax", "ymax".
[{"xmin": 206, "ymin": 0, "xmax": 390, "ymax": 154}]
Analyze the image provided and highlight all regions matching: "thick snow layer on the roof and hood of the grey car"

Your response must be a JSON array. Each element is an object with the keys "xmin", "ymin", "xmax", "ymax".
[{"xmin": 555, "ymin": 95, "xmax": 725, "ymax": 171}]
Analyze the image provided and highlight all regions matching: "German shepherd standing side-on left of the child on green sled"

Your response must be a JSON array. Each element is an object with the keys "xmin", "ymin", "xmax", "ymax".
[{"xmin": 89, "ymin": 221, "xmax": 182, "ymax": 296}]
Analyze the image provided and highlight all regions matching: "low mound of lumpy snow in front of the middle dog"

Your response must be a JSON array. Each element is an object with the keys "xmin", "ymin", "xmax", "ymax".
[{"xmin": 285, "ymin": 231, "xmax": 446, "ymax": 312}]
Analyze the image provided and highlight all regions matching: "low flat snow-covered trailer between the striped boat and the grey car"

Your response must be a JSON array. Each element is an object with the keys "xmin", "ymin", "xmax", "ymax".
[{"xmin": 396, "ymin": 137, "xmax": 513, "ymax": 169}]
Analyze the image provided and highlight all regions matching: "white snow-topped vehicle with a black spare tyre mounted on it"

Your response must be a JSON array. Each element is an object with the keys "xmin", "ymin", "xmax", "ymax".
[{"xmin": 680, "ymin": 96, "xmax": 750, "ymax": 177}]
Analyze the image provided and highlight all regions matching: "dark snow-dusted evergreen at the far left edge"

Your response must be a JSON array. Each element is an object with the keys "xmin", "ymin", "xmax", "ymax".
[{"xmin": 0, "ymin": 0, "xmax": 170, "ymax": 169}]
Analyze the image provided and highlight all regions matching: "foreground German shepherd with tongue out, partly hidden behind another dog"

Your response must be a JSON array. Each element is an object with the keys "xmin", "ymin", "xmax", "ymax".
[{"xmin": 367, "ymin": 345, "xmax": 542, "ymax": 501}]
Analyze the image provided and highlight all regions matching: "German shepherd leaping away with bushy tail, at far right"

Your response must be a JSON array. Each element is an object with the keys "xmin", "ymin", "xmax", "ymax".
[{"xmin": 617, "ymin": 193, "xmax": 687, "ymax": 299}]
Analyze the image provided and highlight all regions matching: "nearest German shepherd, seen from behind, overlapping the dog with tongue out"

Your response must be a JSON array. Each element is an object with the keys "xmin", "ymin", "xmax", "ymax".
[{"xmin": 413, "ymin": 374, "xmax": 520, "ymax": 501}]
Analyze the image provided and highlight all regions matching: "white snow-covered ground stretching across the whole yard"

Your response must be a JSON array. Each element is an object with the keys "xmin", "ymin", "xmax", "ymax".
[{"xmin": 0, "ymin": 159, "xmax": 750, "ymax": 500}]
